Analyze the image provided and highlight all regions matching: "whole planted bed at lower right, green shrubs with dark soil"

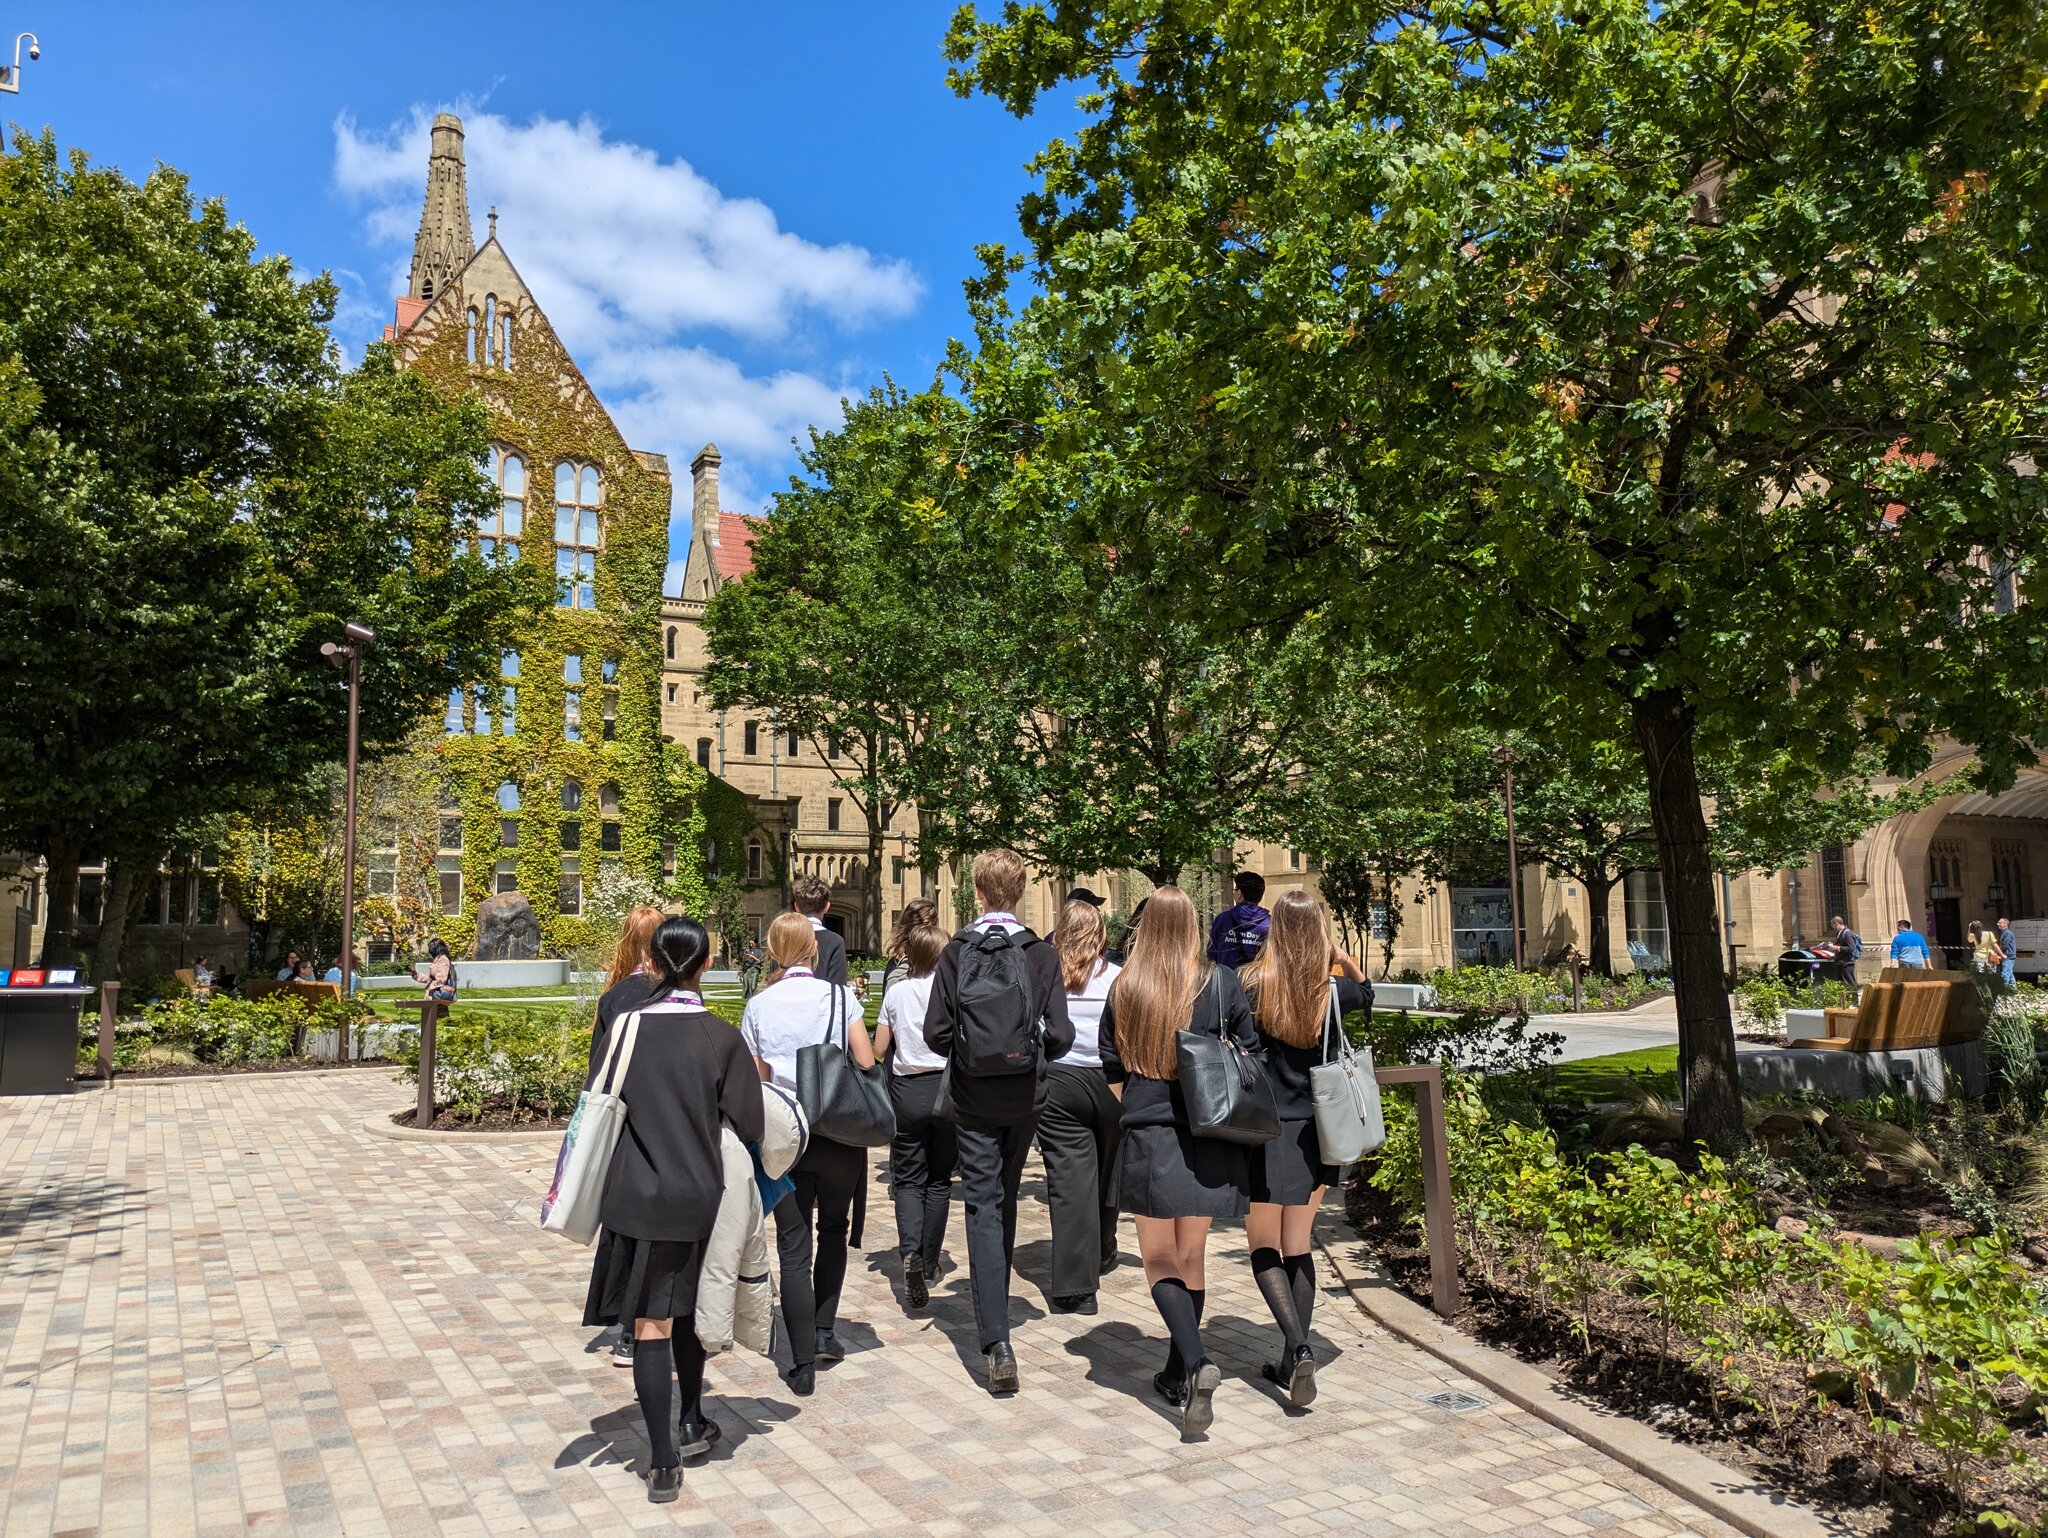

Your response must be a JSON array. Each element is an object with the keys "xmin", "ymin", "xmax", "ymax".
[{"xmin": 1348, "ymin": 1075, "xmax": 2048, "ymax": 1532}]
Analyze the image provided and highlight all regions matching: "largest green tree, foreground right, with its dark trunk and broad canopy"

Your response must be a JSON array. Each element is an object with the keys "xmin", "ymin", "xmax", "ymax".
[{"xmin": 948, "ymin": 0, "xmax": 2048, "ymax": 1145}]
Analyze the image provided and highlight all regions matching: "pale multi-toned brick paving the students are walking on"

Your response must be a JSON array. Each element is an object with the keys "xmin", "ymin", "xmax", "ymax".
[{"xmin": 0, "ymin": 1071, "xmax": 1731, "ymax": 1538}]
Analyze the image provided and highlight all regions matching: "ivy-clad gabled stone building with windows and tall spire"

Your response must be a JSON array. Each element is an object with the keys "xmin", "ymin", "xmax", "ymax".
[{"xmin": 376, "ymin": 113, "xmax": 702, "ymax": 950}]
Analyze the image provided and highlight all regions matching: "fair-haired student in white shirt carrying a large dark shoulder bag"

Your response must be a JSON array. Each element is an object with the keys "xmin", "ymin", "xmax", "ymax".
[{"xmin": 739, "ymin": 913, "xmax": 874, "ymax": 1395}]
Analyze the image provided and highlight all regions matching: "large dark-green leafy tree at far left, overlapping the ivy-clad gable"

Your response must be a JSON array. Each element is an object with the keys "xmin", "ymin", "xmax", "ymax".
[{"xmin": 0, "ymin": 133, "xmax": 549, "ymax": 974}]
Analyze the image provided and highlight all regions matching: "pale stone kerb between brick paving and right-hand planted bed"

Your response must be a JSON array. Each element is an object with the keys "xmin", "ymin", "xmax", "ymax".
[{"xmin": 1317, "ymin": 1236, "xmax": 1843, "ymax": 1538}]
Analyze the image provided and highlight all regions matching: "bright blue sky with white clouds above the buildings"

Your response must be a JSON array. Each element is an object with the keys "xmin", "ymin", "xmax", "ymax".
[{"xmin": 12, "ymin": 0, "xmax": 1061, "ymax": 589}]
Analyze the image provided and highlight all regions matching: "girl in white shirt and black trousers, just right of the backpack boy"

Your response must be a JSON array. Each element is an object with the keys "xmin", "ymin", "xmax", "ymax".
[{"xmin": 1038, "ymin": 893, "xmax": 1122, "ymax": 1315}]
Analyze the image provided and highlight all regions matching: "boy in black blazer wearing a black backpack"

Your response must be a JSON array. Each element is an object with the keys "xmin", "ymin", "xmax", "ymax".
[{"xmin": 924, "ymin": 850, "xmax": 1073, "ymax": 1395}]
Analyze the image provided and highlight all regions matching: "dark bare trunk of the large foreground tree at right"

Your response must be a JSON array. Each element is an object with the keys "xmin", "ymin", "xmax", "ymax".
[{"xmin": 1632, "ymin": 690, "xmax": 1747, "ymax": 1153}]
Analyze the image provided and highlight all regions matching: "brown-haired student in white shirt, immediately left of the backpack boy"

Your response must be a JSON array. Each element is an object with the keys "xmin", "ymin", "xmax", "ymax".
[{"xmin": 874, "ymin": 921, "xmax": 961, "ymax": 1309}]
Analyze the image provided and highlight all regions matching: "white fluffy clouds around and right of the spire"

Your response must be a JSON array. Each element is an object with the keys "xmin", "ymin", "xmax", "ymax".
[{"xmin": 334, "ymin": 106, "xmax": 924, "ymax": 593}]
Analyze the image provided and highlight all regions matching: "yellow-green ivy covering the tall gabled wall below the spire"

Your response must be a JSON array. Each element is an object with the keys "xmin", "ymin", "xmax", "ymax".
[{"xmin": 395, "ymin": 240, "xmax": 709, "ymax": 954}]
